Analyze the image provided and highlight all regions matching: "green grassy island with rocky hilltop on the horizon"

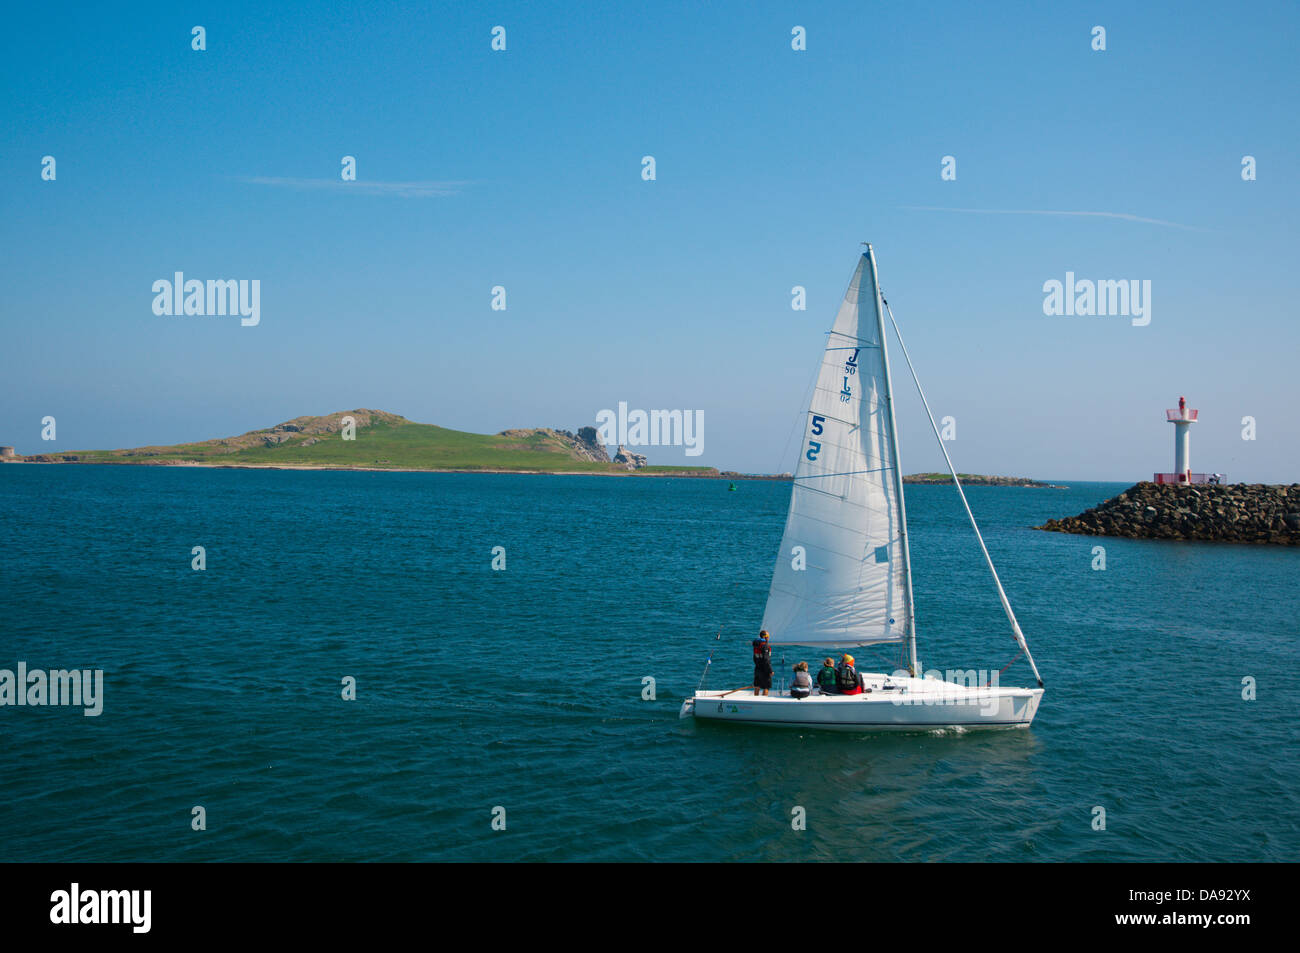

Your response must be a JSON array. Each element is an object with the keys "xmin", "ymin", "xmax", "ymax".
[{"xmin": 26, "ymin": 410, "xmax": 716, "ymax": 475}]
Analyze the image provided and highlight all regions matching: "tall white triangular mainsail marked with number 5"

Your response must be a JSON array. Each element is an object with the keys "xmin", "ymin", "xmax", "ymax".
[{"xmin": 763, "ymin": 247, "xmax": 913, "ymax": 646}]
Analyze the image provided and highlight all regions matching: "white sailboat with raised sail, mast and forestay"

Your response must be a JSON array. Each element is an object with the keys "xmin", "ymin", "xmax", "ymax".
[{"xmin": 680, "ymin": 244, "xmax": 1043, "ymax": 731}]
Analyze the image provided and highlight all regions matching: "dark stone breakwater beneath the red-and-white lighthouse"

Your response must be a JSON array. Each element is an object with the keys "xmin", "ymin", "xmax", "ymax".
[{"xmin": 1035, "ymin": 482, "xmax": 1300, "ymax": 546}]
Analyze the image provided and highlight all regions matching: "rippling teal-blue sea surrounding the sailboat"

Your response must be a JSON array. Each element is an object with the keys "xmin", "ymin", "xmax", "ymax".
[{"xmin": 0, "ymin": 464, "xmax": 1300, "ymax": 862}]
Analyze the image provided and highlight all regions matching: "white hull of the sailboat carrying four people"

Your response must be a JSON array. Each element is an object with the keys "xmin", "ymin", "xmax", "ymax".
[{"xmin": 681, "ymin": 673, "xmax": 1043, "ymax": 731}]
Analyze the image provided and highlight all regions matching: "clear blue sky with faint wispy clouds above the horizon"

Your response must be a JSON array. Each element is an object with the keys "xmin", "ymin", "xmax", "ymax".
[{"xmin": 0, "ymin": 3, "xmax": 1300, "ymax": 482}]
